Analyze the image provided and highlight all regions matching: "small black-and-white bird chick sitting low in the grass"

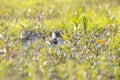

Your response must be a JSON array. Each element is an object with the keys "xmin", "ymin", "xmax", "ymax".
[{"xmin": 45, "ymin": 31, "xmax": 64, "ymax": 47}]
